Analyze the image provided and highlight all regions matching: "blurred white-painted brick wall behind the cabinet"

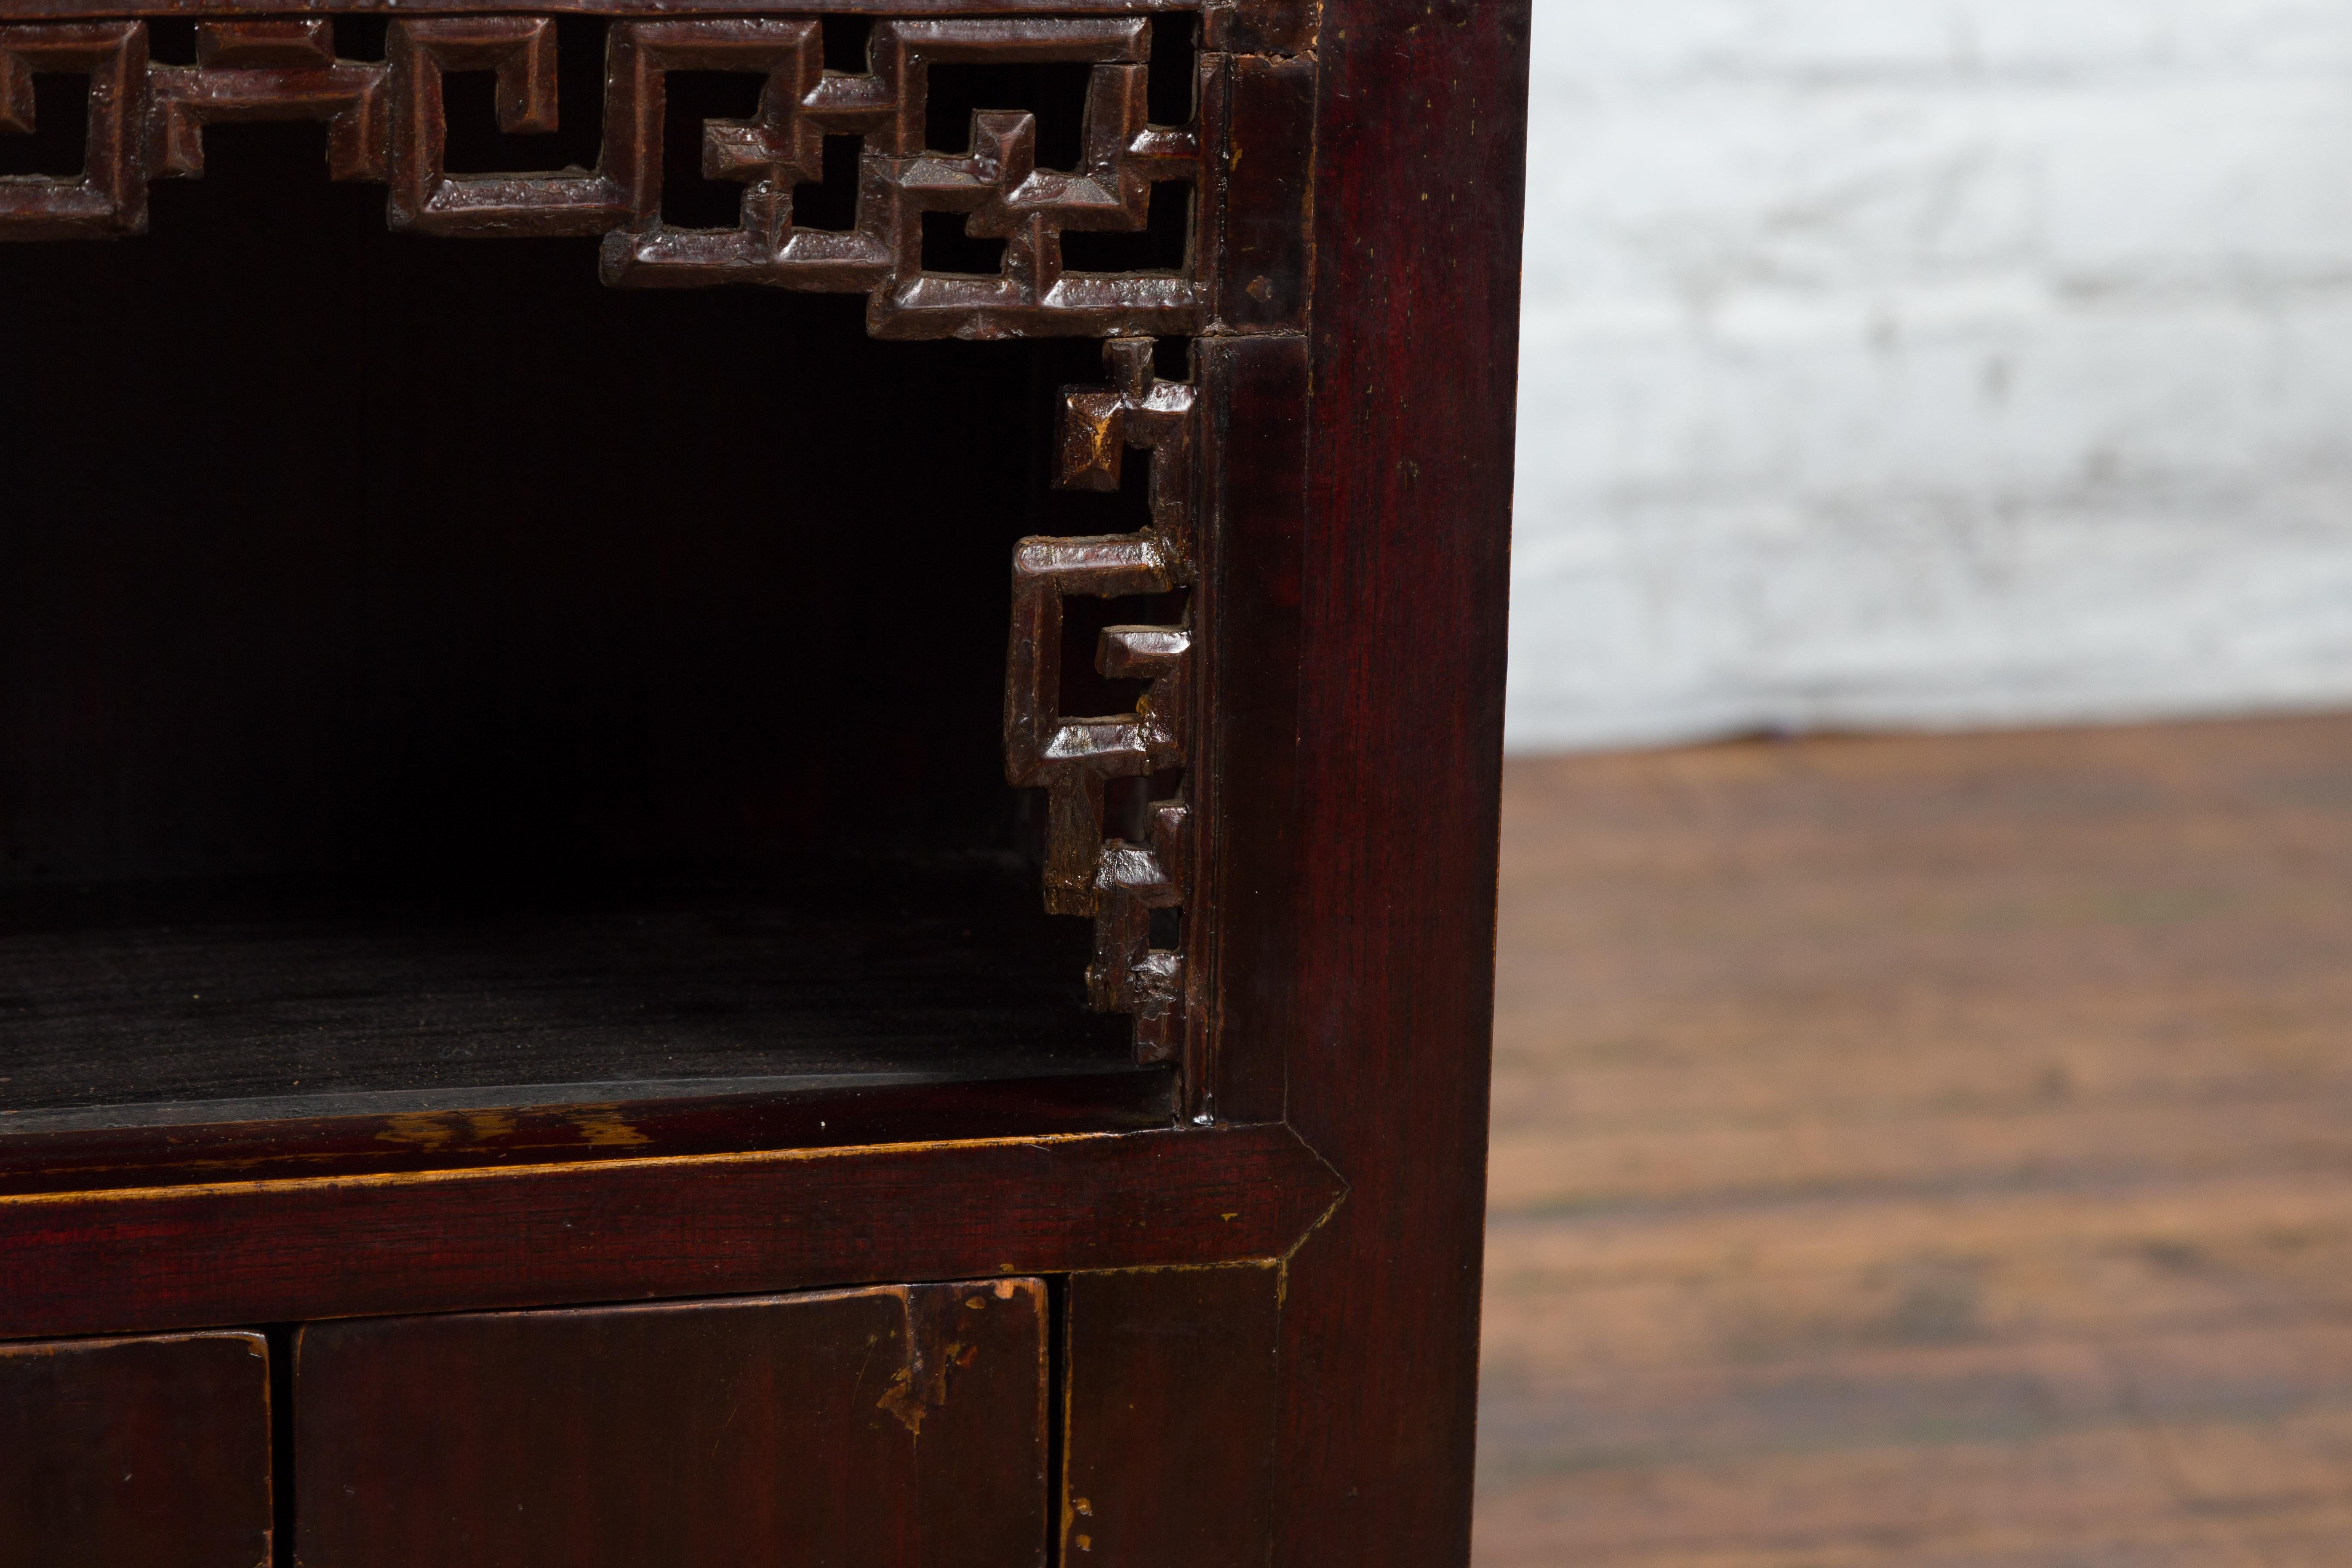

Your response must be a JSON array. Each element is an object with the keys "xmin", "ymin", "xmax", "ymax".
[{"xmin": 1510, "ymin": 0, "xmax": 2352, "ymax": 750}]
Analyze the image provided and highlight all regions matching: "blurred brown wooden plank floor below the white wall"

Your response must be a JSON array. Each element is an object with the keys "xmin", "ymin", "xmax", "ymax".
[{"xmin": 1477, "ymin": 720, "xmax": 2352, "ymax": 1568}]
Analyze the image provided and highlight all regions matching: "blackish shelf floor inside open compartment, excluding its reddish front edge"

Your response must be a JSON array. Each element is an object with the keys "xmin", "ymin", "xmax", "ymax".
[{"xmin": 0, "ymin": 856, "xmax": 1131, "ymax": 1131}]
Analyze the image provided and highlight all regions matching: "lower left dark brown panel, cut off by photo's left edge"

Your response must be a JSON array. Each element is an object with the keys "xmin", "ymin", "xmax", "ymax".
[{"xmin": 0, "ymin": 1333, "xmax": 270, "ymax": 1568}]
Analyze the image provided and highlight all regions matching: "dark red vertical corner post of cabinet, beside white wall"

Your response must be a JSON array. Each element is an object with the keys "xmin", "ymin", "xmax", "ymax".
[{"xmin": 1275, "ymin": 0, "xmax": 1529, "ymax": 1568}]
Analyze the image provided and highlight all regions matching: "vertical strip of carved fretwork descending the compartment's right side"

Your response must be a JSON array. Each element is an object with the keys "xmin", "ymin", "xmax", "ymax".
[{"xmin": 1004, "ymin": 339, "xmax": 1197, "ymax": 1060}]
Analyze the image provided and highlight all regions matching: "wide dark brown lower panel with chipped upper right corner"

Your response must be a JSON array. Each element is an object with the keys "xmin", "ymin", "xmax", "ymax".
[{"xmin": 294, "ymin": 1279, "xmax": 1047, "ymax": 1568}]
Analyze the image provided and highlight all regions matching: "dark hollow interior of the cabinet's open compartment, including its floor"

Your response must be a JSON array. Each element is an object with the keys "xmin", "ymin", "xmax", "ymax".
[{"xmin": 0, "ymin": 83, "xmax": 1174, "ymax": 1166}]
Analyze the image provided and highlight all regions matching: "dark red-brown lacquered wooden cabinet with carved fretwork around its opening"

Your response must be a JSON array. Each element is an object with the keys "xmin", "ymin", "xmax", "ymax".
[{"xmin": 0, "ymin": 0, "xmax": 1526, "ymax": 1568}]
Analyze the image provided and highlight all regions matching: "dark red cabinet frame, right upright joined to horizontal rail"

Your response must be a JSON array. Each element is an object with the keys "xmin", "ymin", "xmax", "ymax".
[{"xmin": 0, "ymin": 0, "xmax": 1526, "ymax": 1568}]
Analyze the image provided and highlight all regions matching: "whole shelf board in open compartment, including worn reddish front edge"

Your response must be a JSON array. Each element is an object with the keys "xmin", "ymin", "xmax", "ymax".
[{"xmin": 0, "ymin": 858, "xmax": 1171, "ymax": 1187}]
